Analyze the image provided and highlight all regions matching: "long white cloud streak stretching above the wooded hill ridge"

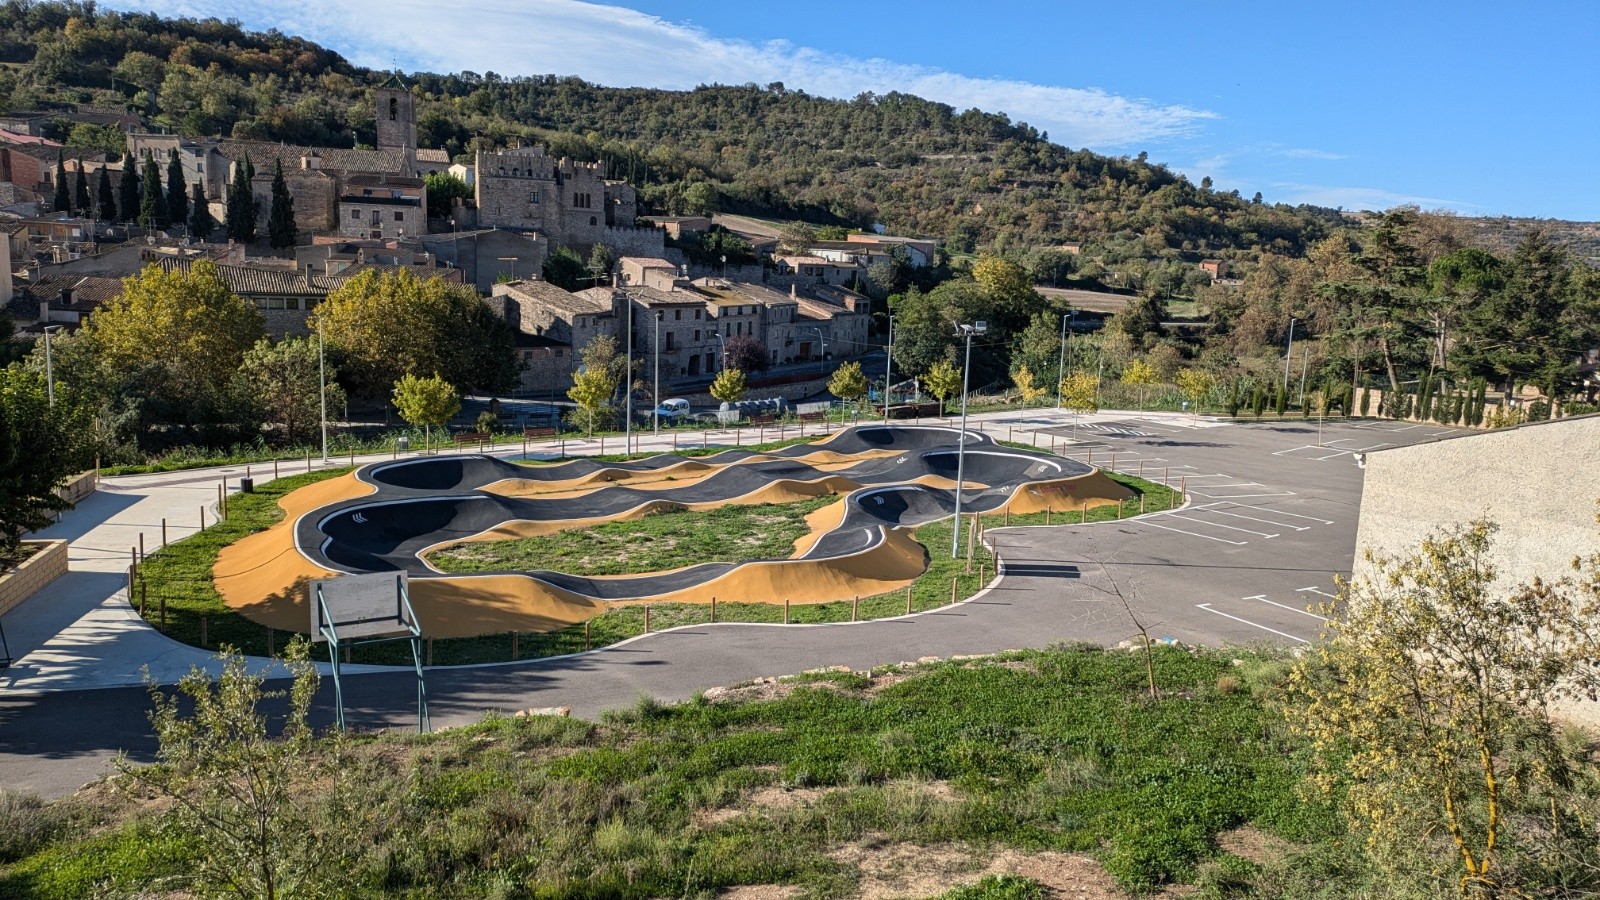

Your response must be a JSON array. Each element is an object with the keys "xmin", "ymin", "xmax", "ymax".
[{"xmin": 96, "ymin": 0, "xmax": 1216, "ymax": 149}]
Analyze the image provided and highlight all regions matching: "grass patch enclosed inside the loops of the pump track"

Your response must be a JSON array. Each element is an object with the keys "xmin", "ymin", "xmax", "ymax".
[{"xmin": 429, "ymin": 495, "xmax": 838, "ymax": 575}]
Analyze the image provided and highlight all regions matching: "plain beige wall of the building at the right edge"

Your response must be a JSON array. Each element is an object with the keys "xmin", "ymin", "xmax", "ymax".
[{"xmin": 1355, "ymin": 416, "xmax": 1600, "ymax": 586}]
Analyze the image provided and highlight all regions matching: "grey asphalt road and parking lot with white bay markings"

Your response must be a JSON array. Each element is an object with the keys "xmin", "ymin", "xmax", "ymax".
[{"xmin": 0, "ymin": 412, "xmax": 1461, "ymax": 796}]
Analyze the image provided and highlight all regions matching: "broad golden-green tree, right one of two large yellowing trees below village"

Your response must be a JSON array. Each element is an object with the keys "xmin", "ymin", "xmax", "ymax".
[{"xmin": 317, "ymin": 269, "xmax": 517, "ymax": 399}]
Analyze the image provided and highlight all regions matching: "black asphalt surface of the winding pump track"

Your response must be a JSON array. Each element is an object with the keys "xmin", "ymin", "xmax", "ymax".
[{"xmin": 296, "ymin": 426, "xmax": 1091, "ymax": 601}]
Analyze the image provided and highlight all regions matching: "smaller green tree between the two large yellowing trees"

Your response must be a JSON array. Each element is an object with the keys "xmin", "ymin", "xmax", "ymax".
[{"xmin": 238, "ymin": 338, "xmax": 344, "ymax": 445}]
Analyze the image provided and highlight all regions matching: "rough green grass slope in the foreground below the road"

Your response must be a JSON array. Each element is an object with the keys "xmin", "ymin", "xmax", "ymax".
[{"xmin": 0, "ymin": 647, "xmax": 1337, "ymax": 900}]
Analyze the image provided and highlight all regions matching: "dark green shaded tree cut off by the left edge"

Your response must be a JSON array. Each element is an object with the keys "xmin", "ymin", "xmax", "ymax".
[{"xmin": 0, "ymin": 365, "xmax": 83, "ymax": 573}]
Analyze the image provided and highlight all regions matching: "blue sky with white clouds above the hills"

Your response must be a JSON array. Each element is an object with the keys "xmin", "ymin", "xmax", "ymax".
[{"xmin": 101, "ymin": 0, "xmax": 1600, "ymax": 221}]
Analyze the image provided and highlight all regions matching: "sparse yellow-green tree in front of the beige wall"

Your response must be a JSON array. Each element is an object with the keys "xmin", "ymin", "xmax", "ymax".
[{"xmin": 1288, "ymin": 519, "xmax": 1600, "ymax": 897}]
